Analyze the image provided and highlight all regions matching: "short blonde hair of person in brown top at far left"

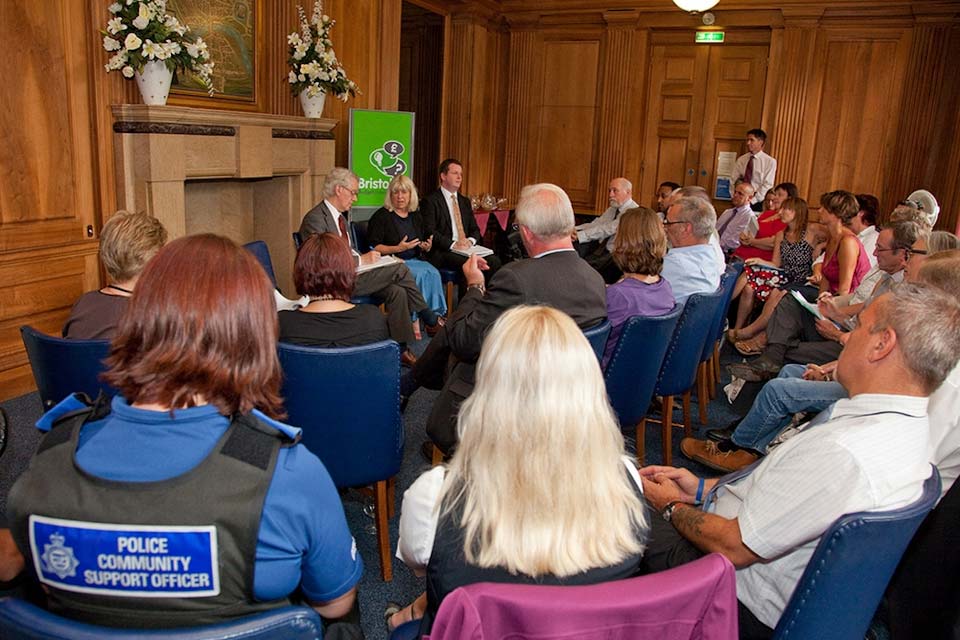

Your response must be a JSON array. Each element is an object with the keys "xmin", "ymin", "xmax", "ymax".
[{"xmin": 100, "ymin": 211, "xmax": 167, "ymax": 282}]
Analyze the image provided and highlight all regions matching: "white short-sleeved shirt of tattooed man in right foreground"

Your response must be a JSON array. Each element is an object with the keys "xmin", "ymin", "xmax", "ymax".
[{"xmin": 709, "ymin": 394, "xmax": 930, "ymax": 628}]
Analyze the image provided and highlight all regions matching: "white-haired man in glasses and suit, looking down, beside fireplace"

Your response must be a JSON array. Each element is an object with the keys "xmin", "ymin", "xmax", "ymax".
[{"xmin": 300, "ymin": 167, "xmax": 440, "ymax": 366}]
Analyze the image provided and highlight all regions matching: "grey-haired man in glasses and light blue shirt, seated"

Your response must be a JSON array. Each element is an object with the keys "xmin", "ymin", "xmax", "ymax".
[{"xmin": 660, "ymin": 197, "xmax": 725, "ymax": 304}]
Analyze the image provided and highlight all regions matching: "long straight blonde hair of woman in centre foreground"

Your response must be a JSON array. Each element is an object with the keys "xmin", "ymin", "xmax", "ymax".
[{"xmin": 440, "ymin": 306, "xmax": 647, "ymax": 577}]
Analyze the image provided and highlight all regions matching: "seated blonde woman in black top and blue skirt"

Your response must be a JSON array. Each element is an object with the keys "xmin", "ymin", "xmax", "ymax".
[{"xmin": 367, "ymin": 175, "xmax": 447, "ymax": 330}]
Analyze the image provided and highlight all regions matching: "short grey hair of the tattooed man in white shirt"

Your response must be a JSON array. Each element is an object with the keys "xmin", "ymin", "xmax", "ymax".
[{"xmin": 867, "ymin": 282, "xmax": 960, "ymax": 393}]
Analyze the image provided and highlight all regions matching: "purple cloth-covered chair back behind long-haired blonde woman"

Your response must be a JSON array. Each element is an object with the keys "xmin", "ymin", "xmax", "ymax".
[{"xmin": 424, "ymin": 553, "xmax": 737, "ymax": 640}]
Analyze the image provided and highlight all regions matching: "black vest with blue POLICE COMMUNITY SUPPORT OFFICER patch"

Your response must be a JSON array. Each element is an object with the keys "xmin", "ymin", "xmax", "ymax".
[{"xmin": 8, "ymin": 401, "xmax": 293, "ymax": 629}]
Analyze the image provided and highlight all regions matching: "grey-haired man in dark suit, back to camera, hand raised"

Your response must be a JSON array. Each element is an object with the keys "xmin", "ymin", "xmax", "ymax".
[{"xmin": 413, "ymin": 184, "xmax": 607, "ymax": 454}]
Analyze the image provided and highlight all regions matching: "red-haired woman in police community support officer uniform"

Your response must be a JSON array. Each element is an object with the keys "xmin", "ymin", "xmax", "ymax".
[{"xmin": 8, "ymin": 234, "xmax": 363, "ymax": 628}]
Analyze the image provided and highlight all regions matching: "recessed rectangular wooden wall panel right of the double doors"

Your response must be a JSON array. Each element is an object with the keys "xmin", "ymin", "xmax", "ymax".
[{"xmin": 808, "ymin": 28, "xmax": 909, "ymax": 205}]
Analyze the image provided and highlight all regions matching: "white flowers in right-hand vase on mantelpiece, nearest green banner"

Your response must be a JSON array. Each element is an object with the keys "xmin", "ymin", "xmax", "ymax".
[{"xmin": 287, "ymin": 0, "xmax": 361, "ymax": 102}]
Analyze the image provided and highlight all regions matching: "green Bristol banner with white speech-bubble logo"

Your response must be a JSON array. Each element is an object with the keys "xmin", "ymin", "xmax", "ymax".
[{"xmin": 350, "ymin": 109, "xmax": 414, "ymax": 207}]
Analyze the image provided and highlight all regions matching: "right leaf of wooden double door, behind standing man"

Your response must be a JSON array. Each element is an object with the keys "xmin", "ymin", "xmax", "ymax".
[{"xmin": 694, "ymin": 45, "xmax": 769, "ymax": 212}]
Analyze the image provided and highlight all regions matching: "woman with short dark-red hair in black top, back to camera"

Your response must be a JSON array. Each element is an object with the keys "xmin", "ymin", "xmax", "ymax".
[{"xmin": 279, "ymin": 233, "xmax": 388, "ymax": 349}]
